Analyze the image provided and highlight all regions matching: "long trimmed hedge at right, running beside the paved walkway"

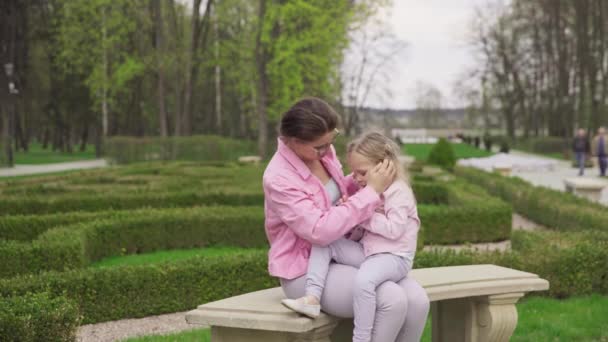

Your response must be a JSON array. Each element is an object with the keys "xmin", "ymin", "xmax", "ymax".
[{"xmin": 455, "ymin": 167, "xmax": 608, "ymax": 231}]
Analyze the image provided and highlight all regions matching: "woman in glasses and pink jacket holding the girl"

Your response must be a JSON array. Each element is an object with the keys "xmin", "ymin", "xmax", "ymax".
[{"xmin": 264, "ymin": 98, "xmax": 429, "ymax": 342}]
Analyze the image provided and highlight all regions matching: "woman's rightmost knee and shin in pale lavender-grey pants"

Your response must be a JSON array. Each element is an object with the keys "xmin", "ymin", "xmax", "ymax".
[{"xmin": 394, "ymin": 277, "xmax": 430, "ymax": 342}]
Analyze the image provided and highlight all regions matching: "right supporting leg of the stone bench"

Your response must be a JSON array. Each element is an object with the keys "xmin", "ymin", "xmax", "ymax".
[{"xmin": 431, "ymin": 293, "xmax": 524, "ymax": 342}]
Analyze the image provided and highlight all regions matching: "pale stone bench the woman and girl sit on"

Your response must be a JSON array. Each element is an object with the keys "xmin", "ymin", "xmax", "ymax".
[{"xmin": 186, "ymin": 265, "xmax": 549, "ymax": 342}]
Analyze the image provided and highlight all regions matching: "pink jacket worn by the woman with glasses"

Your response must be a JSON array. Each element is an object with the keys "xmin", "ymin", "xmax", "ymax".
[{"xmin": 263, "ymin": 139, "xmax": 381, "ymax": 279}]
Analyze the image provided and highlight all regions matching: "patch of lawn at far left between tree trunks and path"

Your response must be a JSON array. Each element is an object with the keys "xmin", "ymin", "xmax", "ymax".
[{"xmin": 15, "ymin": 143, "xmax": 95, "ymax": 165}]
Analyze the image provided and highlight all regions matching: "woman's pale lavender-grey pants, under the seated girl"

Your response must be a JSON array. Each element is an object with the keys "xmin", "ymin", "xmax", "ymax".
[{"xmin": 280, "ymin": 238, "xmax": 429, "ymax": 342}]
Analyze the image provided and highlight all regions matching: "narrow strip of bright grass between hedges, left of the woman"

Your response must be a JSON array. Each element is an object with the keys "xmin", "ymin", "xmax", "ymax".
[{"xmin": 89, "ymin": 247, "xmax": 255, "ymax": 268}]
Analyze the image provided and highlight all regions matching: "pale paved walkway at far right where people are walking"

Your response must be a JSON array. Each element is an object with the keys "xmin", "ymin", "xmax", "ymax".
[{"xmin": 511, "ymin": 151, "xmax": 608, "ymax": 205}]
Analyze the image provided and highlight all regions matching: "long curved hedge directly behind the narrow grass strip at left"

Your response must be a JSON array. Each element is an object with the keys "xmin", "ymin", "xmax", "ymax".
[{"xmin": 0, "ymin": 206, "xmax": 267, "ymax": 277}]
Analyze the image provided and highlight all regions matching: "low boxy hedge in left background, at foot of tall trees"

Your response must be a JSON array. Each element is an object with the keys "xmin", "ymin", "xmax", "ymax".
[{"xmin": 104, "ymin": 135, "xmax": 257, "ymax": 164}]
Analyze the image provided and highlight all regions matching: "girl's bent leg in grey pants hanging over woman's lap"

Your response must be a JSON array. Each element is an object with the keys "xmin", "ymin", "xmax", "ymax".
[{"xmin": 353, "ymin": 253, "xmax": 410, "ymax": 342}]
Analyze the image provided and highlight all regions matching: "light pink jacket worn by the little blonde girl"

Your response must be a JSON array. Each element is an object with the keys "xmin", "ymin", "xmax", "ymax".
[{"xmin": 353, "ymin": 181, "xmax": 420, "ymax": 256}]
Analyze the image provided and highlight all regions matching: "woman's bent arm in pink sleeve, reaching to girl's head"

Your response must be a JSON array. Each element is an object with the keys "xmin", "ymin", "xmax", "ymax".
[{"xmin": 264, "ymin": 177, "xmax": 380, "ymax": 245}]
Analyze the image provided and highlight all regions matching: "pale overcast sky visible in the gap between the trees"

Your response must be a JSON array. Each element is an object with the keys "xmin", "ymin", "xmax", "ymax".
[{"xmin": 366, "ymin": 0, "xmax": 490, "ymax": 109}]
